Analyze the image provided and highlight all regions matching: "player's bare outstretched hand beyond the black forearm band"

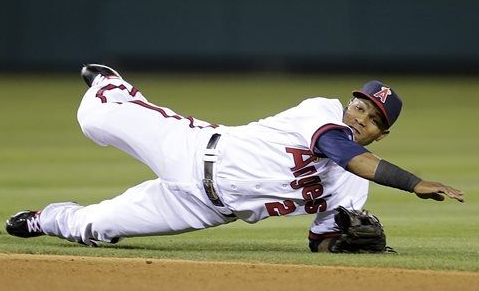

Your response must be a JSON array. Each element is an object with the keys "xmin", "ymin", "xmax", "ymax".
[{"xmin": 414, "ymin": 180, "xmax": 464, "ymax": 202}]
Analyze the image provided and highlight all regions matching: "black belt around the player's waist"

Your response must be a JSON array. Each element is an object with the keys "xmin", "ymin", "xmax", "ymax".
[{"xmin": 203, "ymin": 133, "xmax": 236, "ymax": 217}]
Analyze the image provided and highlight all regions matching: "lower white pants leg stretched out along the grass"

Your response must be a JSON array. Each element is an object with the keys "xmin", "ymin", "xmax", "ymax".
[{"xmin": 40, "ymin": 179, "xmax": 234, "ymax": 245}]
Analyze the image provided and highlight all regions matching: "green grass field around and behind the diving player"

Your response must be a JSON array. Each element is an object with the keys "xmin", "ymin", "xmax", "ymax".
[{"xmin": 0, "ymin": 73, "xmax": 479, "ymax": 272}]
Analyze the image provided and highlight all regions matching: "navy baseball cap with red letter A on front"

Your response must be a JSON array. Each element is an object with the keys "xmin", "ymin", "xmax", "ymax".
[{"xmin": 353, "ymin": 80, "xmax": 402, "ymax": 128}]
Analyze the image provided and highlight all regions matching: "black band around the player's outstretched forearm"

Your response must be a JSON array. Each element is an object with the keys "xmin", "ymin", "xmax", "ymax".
[{"xmin": 373, "ymin": 160, "xmax": 421, "ymax": 192}]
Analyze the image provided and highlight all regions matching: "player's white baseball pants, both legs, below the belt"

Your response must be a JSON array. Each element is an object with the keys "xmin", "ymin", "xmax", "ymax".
[{"xmin": 40, "ymin": 76, "xmax": 235, "ymax": 245}]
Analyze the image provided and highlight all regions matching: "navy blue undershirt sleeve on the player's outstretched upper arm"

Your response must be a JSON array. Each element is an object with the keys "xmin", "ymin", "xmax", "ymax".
[{"xmin": 312, "ymin": 128, "xmax": 368, "ymax": 169}]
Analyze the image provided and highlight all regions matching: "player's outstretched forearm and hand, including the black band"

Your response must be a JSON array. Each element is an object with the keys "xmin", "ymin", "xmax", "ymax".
[{"xmin": 346, "ymin": 152, "xmax": 464, "ymax": 202}]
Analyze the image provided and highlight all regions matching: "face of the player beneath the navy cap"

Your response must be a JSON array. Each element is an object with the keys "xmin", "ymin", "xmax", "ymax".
[{"xmin": 343, "ymin": 98, "xmax": 389, "ymax": 145}]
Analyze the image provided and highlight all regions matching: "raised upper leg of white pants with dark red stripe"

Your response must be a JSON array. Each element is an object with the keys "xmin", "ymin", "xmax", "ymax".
[{"xmin": 77, "ymin": 76, "xmax": 216, "ymax": 182}]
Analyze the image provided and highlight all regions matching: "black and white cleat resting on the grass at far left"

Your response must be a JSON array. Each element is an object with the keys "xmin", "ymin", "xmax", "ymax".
[{"xmin": 5, "ymin": 210, "xmax": 45, "ymax": 238}]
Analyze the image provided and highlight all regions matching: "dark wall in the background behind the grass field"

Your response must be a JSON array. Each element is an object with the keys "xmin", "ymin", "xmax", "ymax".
[{"xmin": 0, "ymin": 0, "xmax": 479, "ymax": 73}]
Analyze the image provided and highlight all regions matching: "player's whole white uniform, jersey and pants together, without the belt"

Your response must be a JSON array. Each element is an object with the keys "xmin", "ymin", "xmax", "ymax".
[{"xmin": 40, "ymin": 76, "xmax": 368, "ymax": 245}]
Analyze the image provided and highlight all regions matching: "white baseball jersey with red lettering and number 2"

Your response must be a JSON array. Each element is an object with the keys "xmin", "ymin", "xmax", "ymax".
[{"xmin": 216, "ymin": 98, "xmax": 369, "ymax": 233}]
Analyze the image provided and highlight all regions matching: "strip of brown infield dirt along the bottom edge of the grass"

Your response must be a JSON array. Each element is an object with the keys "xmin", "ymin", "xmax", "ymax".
[{"xmin": 0, "ymin": 254, "xmax": 479, "ymax": 291}]
